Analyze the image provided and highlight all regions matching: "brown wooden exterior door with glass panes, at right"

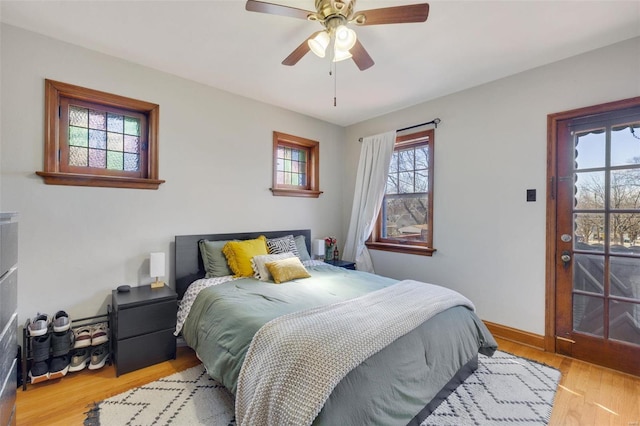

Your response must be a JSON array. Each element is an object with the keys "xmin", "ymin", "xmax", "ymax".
[{"xmin": 550, "ymin": 98, "xmax": 640, "ymax": 375}]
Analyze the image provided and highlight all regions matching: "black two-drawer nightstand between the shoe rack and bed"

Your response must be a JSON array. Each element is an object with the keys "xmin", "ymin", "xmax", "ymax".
[{"xmin": 111, "ymin": 285, "xmax": 178, "ymax": 376}]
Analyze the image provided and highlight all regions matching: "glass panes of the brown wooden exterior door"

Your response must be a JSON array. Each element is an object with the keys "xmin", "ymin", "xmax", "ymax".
[{"xmin": 572, "ymin": 121, "xmax": 640, "ymax": 345}]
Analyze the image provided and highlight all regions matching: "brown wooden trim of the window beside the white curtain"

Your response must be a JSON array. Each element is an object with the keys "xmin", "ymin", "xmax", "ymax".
[{"xmin": 365, "ymin": 129, "xmax": 437, "ymax": 256}]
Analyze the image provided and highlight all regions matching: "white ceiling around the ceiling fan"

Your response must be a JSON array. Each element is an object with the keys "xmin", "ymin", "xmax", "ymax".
[{"xmin": 0, "ymin": 0, "xmax": 640, "ymax": 126}]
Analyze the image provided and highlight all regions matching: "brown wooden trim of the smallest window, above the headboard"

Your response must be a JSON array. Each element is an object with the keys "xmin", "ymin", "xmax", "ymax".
[{"xmin": 270, "ymin": 131, "xmax": 322, "ymax": 198}]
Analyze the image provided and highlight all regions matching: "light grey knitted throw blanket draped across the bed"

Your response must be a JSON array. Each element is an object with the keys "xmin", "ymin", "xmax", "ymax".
[{"xmin": 236, "ymin": 280, "xmax": 474, "ymax": 426}]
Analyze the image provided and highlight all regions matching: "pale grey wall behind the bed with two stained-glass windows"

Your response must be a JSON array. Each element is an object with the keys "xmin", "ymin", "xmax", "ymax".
[{"xmin": 0, "ymin": 25, "xmax": 344, "ymax": 323}]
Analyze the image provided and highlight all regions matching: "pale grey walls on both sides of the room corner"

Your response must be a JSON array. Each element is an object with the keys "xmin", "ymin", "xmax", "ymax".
[{"xmin": 0, "ymin": 25, "xmax": 640, "ymax": 334}]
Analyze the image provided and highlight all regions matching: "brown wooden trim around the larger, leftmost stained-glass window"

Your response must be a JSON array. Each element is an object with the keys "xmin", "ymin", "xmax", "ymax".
[{"xmin": 36, "ymin": 79, "xmax": 165, "ymax": 189}]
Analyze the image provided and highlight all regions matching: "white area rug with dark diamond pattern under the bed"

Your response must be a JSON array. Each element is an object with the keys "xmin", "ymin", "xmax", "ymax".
[{"xmin": 84, "ymin": 351, "xmax": 560, "ymax": 426}]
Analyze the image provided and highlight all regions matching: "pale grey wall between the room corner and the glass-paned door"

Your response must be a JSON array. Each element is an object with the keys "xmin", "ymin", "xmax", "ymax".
[{"xmin": 342, "ymin": 38, "xmax": 640, "ymax": 335}]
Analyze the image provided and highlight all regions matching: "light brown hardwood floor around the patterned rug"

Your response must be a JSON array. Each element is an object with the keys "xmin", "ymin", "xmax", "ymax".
[{"xmin": 17, "ymin": 339, "xmax": 640, "ymax": 426}]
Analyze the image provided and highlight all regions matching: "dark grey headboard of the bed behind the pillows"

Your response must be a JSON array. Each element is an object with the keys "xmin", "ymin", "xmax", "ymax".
[{"xmin": 174, "ymin": 229, "xmax": 311, "ymax": 299}]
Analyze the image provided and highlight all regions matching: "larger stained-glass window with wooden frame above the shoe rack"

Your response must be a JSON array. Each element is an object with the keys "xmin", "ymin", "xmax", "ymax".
[{"xmin": 36, "ymin": 80, "xmax": 164, "ymax": 189}]
